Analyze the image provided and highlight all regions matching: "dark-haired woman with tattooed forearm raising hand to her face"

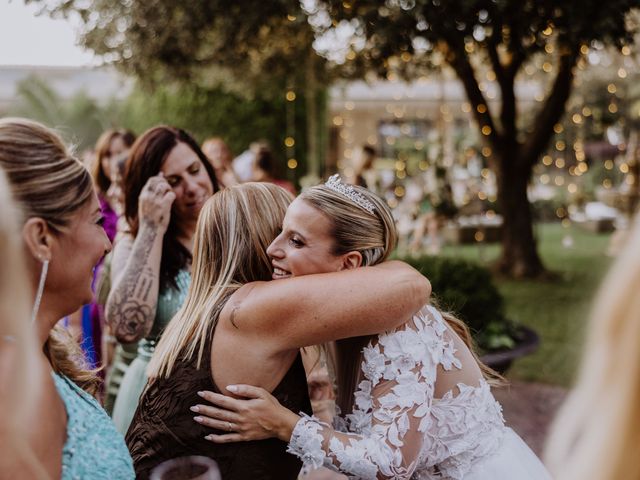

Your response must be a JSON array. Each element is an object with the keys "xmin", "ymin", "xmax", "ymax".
[{"xmin": 106, "ymin": 126, "xmax": 218, "ymax": 433}]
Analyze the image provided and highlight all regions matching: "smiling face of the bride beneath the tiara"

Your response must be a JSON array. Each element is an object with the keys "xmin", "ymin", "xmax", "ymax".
[{"xmin": 267, "ymin": 198, "xmax": 344, "ymax": 280}]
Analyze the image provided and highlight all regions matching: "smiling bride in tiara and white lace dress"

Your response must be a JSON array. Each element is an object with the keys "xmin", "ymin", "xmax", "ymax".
[{"xmin": 192, "ymin": 176, "xmax": 550, "ymax": 480}]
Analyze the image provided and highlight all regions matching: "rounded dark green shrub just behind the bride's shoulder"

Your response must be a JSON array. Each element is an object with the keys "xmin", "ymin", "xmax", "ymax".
[{"xmin": 403, "ymin": 256, "xmax": 515, "ymax": 350}]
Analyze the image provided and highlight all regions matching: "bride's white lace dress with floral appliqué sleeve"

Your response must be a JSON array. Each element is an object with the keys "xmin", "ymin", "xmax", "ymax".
[{"xmin": 288, "ymin": 305, "xmax": 551, "ymax": 480}]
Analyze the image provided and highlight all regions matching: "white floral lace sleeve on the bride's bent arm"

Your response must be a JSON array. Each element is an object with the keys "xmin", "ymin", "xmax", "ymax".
[{"xmin": 288, "ymin": 307, "xmax": 459, "ymax": 479}]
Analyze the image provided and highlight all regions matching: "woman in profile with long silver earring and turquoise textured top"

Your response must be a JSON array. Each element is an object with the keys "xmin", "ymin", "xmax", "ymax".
[{"xmin": 0, "ymin": 118, "xmax": 133, "ymax": 479}]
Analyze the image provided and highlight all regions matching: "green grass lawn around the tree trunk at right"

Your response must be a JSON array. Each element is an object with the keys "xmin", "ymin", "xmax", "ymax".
[{"xmin": 436, "ymin": 224, "xmax": 611, "ymax": 386}]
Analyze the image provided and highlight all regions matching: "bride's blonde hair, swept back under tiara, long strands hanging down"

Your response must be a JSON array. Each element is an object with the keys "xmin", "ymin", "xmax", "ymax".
[{"xmin": 298, "ymin": 184, "xmax": 501, "ymax": 413}]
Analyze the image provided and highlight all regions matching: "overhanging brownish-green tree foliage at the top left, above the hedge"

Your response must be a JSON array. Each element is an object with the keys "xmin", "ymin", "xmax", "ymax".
[{"xmin": 28, "ymin": 0, "xmax": 324, "ymax": 91}]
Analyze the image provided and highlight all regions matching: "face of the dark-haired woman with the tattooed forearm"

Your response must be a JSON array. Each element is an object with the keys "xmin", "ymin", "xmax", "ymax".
[{"xmin": 160, "ymin": 142, "xmax": 213, "ymax": 223}]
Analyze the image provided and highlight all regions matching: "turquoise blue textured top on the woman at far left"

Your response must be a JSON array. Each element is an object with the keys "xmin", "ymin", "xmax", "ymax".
[{"xmin": 53, "ymin": 374, "xmax": 135, "ymax": 480}]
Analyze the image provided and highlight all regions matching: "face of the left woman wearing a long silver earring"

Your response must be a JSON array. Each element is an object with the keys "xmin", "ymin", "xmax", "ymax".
[{"xmin": 47, "ymin": 194, "xmax": 111, "ymax": 313}]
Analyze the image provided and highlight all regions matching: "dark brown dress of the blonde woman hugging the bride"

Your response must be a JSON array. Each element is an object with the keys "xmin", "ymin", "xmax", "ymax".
[{"xmin": 126, "ymin": 330, "xmax": 311, "ymax": 480}]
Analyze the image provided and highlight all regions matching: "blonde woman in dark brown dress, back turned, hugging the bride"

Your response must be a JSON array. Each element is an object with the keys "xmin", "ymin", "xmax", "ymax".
[{"xmin": 126, "ymin": 183, "xmax": 430, "ymax": 480}]
